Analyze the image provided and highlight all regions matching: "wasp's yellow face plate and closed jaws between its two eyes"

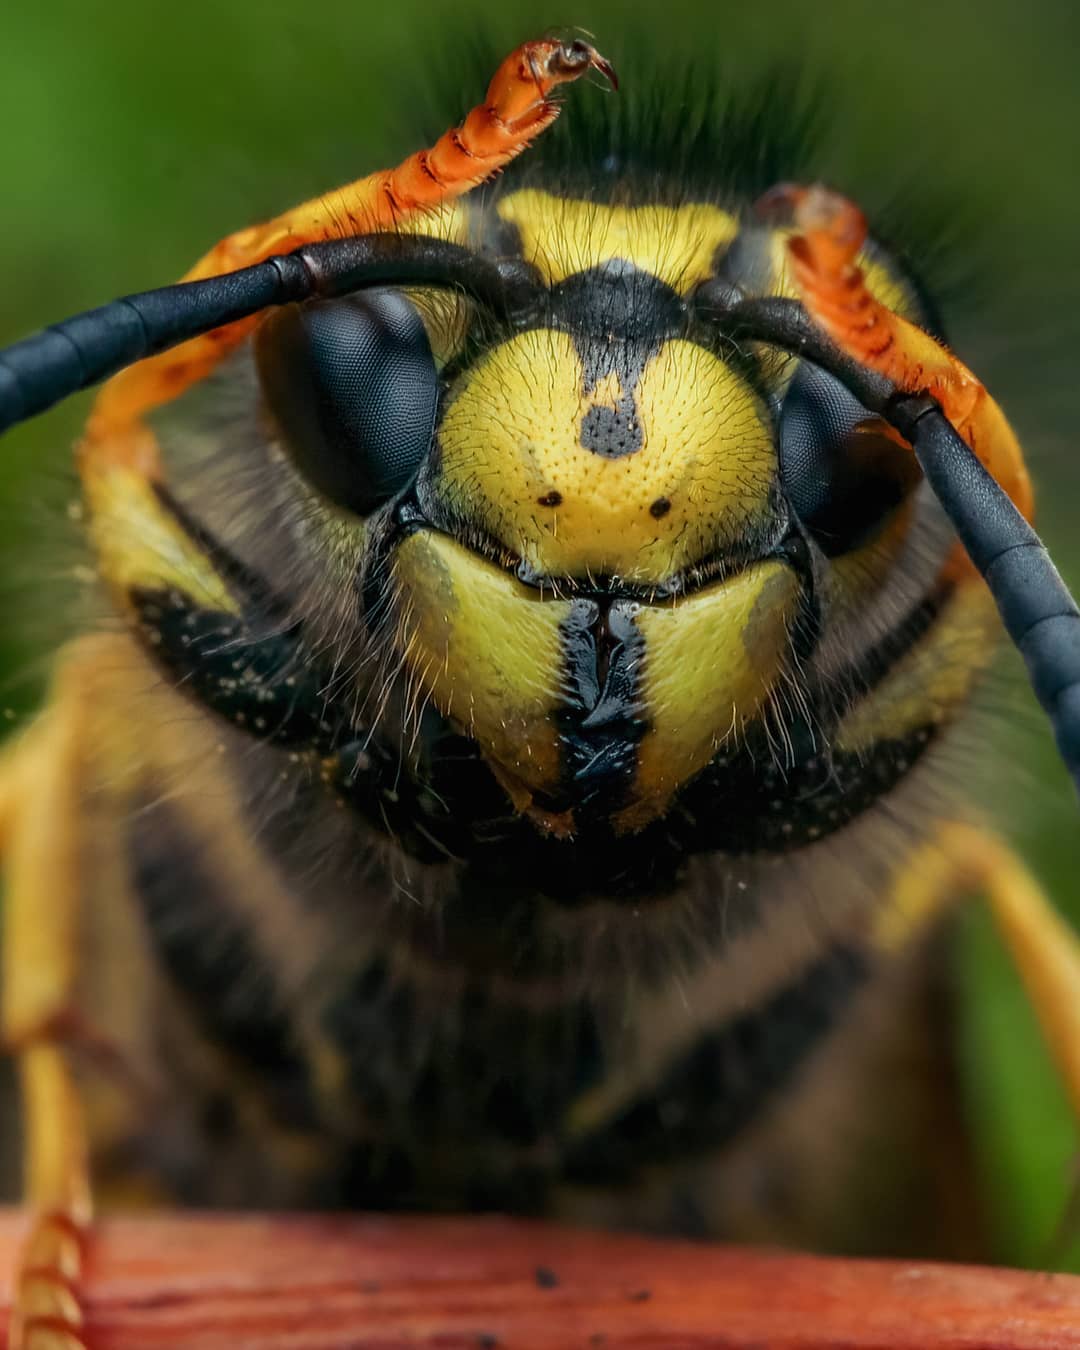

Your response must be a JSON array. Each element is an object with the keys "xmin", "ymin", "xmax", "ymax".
[{"xmin": 393, "ymin": 238, "xmax": 802, "ymax": 830}]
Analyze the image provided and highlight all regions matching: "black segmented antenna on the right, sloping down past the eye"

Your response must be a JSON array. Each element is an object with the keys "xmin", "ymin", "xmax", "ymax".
[{"xmin": 712, "ymin": 295, "xmax": 1080, "ymax": 792}]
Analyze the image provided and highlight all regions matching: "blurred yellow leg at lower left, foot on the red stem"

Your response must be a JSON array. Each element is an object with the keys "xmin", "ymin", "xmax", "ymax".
[{"xmin": 0, "ymin": 639, "xmax": 135, "ymax": 1350}]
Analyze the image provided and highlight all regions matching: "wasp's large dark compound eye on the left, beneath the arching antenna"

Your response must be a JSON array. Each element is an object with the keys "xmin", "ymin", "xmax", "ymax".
[{"xmin": 255, "ymin": 290, "xmax": 439, "ymax": 516}]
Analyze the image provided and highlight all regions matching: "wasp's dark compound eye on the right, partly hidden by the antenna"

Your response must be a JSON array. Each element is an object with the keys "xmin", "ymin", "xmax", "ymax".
[{"xmin": 779, "ymin": 362, "xmax": 921, "ymax": 556}]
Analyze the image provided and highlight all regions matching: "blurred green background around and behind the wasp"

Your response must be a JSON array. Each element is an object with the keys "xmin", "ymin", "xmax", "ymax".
[{"xmin": 0, "ymin": 0, "xmax": 1080, "ymax": 1268}]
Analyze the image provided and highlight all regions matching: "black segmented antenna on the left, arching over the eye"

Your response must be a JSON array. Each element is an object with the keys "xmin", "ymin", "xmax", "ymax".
[{"xmin": 0, "ymin": 234, "xmax": 536, "ymax": 433}]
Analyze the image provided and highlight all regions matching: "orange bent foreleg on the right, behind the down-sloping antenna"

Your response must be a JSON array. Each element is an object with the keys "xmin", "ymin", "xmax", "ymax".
[{"xmin": 767, "ymin": 185, "xmax": 1034, "ymax": 520}]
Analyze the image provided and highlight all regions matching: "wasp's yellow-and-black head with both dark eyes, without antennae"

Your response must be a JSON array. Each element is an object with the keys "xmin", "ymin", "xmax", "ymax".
[{"xmin": 206, "ymin": 190, "xmax": 966, "ymax": 864}]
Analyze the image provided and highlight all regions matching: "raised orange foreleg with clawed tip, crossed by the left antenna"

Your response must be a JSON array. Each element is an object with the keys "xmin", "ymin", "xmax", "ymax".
[{"xmin": 82, "ymin": 39, "xmax": 616, "ymax": 477}]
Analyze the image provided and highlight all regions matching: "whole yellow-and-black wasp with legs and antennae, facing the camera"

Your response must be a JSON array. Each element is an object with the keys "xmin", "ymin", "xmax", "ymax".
[{"xmin": 0, "ymin": 31, "xmax": 1080, "ymax": 1347}]
